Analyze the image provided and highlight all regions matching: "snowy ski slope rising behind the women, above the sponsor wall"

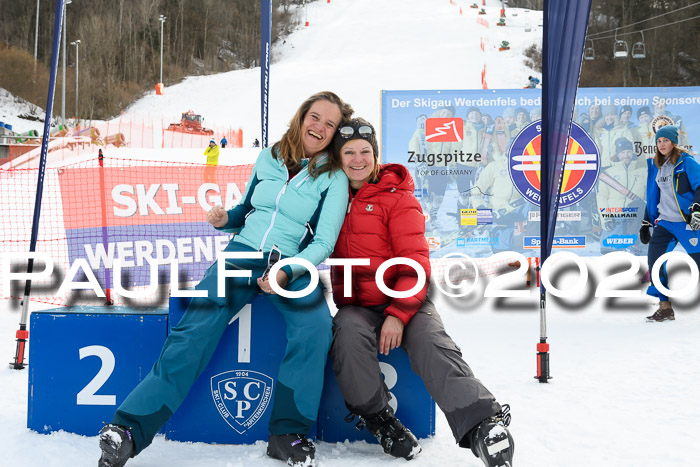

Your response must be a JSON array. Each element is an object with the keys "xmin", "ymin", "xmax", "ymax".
[{"xmin": 112, "ymin": 0, "xmax": 542, "ymax": 146}]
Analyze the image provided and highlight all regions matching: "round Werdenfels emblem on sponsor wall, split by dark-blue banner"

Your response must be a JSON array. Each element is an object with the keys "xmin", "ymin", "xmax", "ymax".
[{"xmin": 508, "ymin": 120, "xmax": 600, "ymax": 208}]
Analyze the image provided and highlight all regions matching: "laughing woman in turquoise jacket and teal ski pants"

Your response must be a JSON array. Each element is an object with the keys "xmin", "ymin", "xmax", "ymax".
[{"xmin": 99, "ymin": 92, "xmax": 352, "ymax": 467}]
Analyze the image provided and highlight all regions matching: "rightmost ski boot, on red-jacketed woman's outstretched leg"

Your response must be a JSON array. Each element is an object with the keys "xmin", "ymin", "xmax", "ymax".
[{"xmin": 467, "ymin": 404, "xmax": 515, "ymax": 467}]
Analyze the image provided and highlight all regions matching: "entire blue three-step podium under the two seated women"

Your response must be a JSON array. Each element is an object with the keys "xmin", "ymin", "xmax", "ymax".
[{"xmin": 27, "ymin": 295, "xmax": 435, "ymax": 444}]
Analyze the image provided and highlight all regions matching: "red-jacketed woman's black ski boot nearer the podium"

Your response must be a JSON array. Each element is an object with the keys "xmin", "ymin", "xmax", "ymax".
[{"xmin": 346, "ymin": 406, "xmax": 422, "ymax": 460}]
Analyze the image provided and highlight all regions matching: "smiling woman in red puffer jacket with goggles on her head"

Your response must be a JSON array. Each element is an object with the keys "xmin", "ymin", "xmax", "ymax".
[{"xmin": 331, "ymin": 118, "xmax": 513, "ymax": 466}]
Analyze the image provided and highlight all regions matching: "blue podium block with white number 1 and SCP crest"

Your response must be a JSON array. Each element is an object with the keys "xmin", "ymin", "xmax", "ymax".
[{"xmin": 165, "ymin": 295, "xmax": 313, "ymax": 444}]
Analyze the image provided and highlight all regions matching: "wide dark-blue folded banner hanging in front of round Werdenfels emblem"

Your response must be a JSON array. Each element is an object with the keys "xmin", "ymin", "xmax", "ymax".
[{"xmin": 540, "ymin": 0, "xmax": 591, "ymax": 270}]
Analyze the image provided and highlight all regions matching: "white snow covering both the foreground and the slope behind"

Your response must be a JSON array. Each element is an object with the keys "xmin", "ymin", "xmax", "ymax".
[{"xmin": 0, "ymin": 0, "xmax": 700, "ymax": 467}]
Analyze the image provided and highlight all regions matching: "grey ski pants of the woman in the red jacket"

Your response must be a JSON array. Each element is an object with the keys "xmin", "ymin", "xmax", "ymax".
[{"xmin": 331, "ymin": 299, "xmax": 501, "ymax": 448}]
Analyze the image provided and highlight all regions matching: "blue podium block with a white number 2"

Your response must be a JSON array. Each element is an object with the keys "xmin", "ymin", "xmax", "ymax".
[{"xmin": 27, "ymin": 306, "xmax": 168, "ymax": 436}]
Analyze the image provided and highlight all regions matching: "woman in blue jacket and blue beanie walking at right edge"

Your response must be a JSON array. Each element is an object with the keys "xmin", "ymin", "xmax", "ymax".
[{"xmin": 639, "ymin": 125, "xmax": 700, "ymax": 322}]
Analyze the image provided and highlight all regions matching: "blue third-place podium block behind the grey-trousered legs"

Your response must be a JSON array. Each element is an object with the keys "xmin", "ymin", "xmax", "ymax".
[{"xmin": 317, "ymin": 347, "xmax": 435, "ymax": 443}]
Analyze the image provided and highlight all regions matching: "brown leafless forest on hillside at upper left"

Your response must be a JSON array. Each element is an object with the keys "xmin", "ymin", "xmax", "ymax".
[{"xmin": 0, "ymin": 0, "xmax": 306, "ymax": 119}]
